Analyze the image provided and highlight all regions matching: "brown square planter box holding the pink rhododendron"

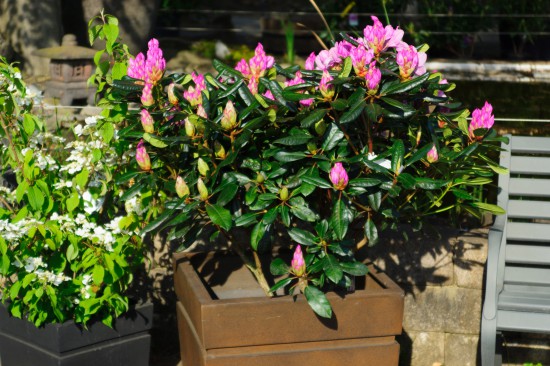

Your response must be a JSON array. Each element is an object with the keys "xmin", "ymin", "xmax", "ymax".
[{"xmin": 174, "ymin": 254, "xmax": 404, "ymax": 366}]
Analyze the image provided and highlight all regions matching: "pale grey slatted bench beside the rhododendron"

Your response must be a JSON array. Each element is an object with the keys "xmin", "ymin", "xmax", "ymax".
[{"xmin": 481, "ymin": 135, "xmax": 550, "ymax": 366}]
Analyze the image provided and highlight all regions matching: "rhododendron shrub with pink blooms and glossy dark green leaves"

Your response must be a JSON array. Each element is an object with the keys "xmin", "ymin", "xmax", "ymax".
[{"xmin": 91, "ymin": 17, "xmax": 508, "ymax": 317}]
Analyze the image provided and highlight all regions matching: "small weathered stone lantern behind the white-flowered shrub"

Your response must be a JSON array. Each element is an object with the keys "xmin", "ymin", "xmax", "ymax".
[{"xmin": 35, "ymin": 34, "xmax": 96, "ymax": 105}]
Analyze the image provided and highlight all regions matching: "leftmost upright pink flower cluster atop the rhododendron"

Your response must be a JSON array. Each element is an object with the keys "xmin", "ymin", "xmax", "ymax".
[{"xmin": 128, "ymin": 38, "xmax": 166, "ymax": 107}]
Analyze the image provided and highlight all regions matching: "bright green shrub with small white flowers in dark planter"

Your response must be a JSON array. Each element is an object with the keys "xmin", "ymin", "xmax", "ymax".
[{"xmin": 0, "ymin": 57, "xmax": 145, "ymax": 326}]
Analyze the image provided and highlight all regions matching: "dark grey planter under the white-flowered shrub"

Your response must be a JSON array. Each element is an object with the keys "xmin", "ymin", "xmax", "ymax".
[{"xmin": 0, "ymin": 303, "xmax": 153, "ymax": 366}]
